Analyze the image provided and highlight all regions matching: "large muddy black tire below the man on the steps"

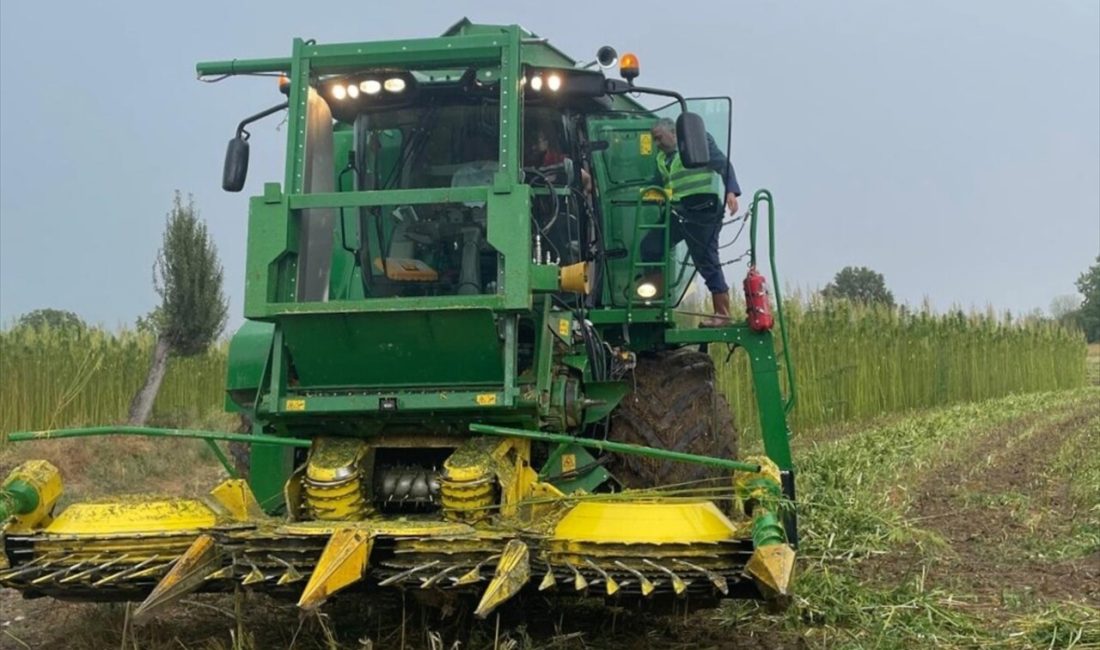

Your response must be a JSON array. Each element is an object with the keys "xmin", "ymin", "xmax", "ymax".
[{"xmin": 609, "ymin": 348, "xmax": 737, "ymax": 488}]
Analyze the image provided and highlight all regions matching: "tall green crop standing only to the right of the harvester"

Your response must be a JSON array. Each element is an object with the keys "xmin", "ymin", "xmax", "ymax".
[{"xmin": 712, "ymin": 298, "xmax": 1087, "ymax": 439}]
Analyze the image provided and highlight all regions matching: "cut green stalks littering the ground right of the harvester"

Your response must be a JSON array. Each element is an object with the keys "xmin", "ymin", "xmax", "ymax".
[{"xmin": 715, "ymin": 389, "xmax": 1100, "ymax": 648}]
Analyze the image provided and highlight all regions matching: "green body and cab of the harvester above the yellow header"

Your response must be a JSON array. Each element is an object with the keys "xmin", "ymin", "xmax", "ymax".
[{"xmin": 198, "ymin": 20, "xmax": 792, "ymax": 510}]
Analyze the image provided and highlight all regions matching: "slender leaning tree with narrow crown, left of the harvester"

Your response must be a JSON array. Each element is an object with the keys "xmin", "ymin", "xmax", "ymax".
[{"xmin": 130, "ymin": 191, "xmax": 229, "ymax": 426}]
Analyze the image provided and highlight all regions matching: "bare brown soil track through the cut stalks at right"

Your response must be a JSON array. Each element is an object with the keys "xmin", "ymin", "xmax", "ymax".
[{"xmin": 895, "ymin": 403, "xmax": 1100, "ymax": 607}]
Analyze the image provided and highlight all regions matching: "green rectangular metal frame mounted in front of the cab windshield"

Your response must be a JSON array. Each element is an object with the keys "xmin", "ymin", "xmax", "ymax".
[{"xmin": 203, "ymin": 31, "xmax": 531, "ymax": 320}]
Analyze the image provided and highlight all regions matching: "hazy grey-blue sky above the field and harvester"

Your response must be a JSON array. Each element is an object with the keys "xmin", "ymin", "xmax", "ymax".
[{"xmin": 0, "ymin": 0, "xmax": 1100, "ymax": 327}]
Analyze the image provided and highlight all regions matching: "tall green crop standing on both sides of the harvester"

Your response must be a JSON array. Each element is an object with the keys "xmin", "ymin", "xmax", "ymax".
[{"xmin": 0, "ymin": 298, "xmax": 1087, "ymax": 431}]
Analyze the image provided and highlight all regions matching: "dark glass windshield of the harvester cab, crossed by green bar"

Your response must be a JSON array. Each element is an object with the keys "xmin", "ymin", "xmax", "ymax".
[{"xmin": 354, "ymin": 93, "xmax": 499, "ymax": 296}]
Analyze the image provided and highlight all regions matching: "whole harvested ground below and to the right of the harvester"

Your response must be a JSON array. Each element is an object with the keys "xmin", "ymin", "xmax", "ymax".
[{"xmin": 0, "ymin": 388, "xmax": 1100, "ymax": 650}]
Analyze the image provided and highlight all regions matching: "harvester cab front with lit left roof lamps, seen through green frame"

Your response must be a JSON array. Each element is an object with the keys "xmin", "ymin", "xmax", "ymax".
[{"xmin": 299, "ymin": 67, "xmax": 514, "ymax": 299}]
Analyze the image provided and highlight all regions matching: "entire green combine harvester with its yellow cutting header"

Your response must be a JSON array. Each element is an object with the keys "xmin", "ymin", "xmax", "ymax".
[{"xmin": 0, "ymin": 20, "xmax": 798, "ymax": 618}]
